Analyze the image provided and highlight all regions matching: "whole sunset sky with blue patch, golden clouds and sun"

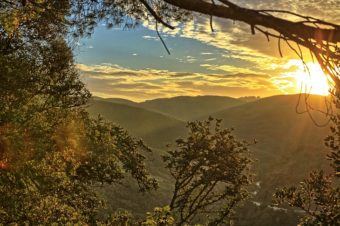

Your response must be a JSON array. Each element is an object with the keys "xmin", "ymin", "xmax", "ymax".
[{"xmin": 75, "ymin": 0, "xmax": 340, "ymax": 101}]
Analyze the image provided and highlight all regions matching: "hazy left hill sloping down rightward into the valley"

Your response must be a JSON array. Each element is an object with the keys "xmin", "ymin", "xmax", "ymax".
[{"xmin": 88, "ymin": 99, "xmax": 185, "ymax": 147}]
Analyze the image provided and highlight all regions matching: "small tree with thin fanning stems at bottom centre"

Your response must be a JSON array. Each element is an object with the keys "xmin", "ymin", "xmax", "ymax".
[{"xmin": 164, "ymin": 118, "xmax": 252, "ymax": 226}]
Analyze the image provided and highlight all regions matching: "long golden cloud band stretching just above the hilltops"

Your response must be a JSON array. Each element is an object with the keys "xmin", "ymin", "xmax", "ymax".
[{"xmin": 77, "ymin": 64, "xmax": 278, "ymax": 101}]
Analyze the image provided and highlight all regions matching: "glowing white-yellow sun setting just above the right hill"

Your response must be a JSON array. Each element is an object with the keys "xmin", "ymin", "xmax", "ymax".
[{"xmin": 294, "ymin": 63, "xmax": 330, "ymax": 96}]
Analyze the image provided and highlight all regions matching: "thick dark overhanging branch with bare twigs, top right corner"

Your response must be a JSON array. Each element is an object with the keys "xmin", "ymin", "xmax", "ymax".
[{"xmin": 163, "ymin": 0, "xmax": 340, "ymax": 90}]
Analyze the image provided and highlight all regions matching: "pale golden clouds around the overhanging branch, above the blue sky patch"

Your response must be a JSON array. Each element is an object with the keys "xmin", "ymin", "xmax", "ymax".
[{"xmin": 140, "ymin": 0, "xmax": 340, "ymax": 75}]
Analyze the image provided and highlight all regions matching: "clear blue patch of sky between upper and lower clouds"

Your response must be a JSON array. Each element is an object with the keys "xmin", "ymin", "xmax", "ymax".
[{"xmin": 76, "ymin": 26, "xmax": 251, "ymax": 73}]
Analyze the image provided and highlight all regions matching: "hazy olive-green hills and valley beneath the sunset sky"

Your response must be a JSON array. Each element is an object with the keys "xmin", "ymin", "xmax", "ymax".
[{"xmin": 88, "ymin": 95, "xmax": 329, "ymax": 225}]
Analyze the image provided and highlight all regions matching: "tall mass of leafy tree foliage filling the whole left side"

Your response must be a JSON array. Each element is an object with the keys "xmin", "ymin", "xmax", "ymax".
[{"xmin": 0, "ymin": 1, "xmax": 157, "ymax": 225}]
